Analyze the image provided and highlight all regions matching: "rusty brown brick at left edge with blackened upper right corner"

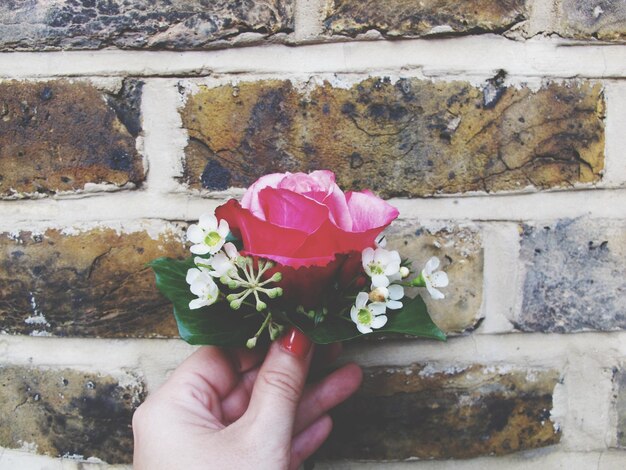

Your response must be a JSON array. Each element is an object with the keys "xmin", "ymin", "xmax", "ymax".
[{"xmin": 0, "ymin": 80, "xmax": 144, "ymax": 198}]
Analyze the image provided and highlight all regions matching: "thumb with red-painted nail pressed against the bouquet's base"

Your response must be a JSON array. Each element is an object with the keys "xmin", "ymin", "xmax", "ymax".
[{"xmin": 246, "ymin": 328, "xmax": 312, "ymax": 442}]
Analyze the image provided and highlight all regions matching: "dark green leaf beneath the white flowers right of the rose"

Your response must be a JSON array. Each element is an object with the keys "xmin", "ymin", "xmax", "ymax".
[{"xmin": 289, "ymin": 296, "xmax": 446, "ymax": 344}]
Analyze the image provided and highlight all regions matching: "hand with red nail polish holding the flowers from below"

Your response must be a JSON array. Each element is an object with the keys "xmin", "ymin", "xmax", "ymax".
[{"xmin": 133, "ymin": 329, "xmax": 361, "ymax": 470}]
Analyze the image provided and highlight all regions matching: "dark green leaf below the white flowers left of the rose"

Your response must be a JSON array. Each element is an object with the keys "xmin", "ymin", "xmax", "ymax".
[{"xmin": 149, "ymin": 258, "xmax": 262, "ymax": 346}]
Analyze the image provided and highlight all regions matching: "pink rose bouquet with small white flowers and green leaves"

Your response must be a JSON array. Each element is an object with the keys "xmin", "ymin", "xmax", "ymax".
[{"xmin": 150, "ymin": 171, "xmax": 448, "ymax": 348}]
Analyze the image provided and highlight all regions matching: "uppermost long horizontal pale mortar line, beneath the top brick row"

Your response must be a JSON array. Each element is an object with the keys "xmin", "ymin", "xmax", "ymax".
[{"xmin": 0, "ymin": 35, "xmax": 626, "ymax": 78}]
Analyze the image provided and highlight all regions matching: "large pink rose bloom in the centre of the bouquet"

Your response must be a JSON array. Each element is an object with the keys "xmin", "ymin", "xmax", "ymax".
[{"xmin": 215, "ymin": 170, "xmax": 398, "ymax": 306}]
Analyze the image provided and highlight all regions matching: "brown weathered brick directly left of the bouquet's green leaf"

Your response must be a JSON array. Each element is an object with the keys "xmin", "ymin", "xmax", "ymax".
[{"xmin": 0, "ymin": 228, "xmax": 186, "ymax": 338}]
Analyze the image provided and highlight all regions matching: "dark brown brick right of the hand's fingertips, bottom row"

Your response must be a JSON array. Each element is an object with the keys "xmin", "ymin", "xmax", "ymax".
[{"xmin": 324, "ymin": 364, "xmax": 560, "ymax": 460}]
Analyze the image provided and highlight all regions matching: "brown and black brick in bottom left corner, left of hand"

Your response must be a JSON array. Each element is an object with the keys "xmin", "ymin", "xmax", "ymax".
[{"xmin": 0, "ymin": 365, "xmax": 145, "ymax": 463}]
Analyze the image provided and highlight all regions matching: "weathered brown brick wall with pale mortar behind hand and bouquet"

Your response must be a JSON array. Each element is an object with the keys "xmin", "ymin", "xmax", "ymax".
[{"xmin": 0, "ymin": 0, "xmax": 626, "ymax": 470}]
